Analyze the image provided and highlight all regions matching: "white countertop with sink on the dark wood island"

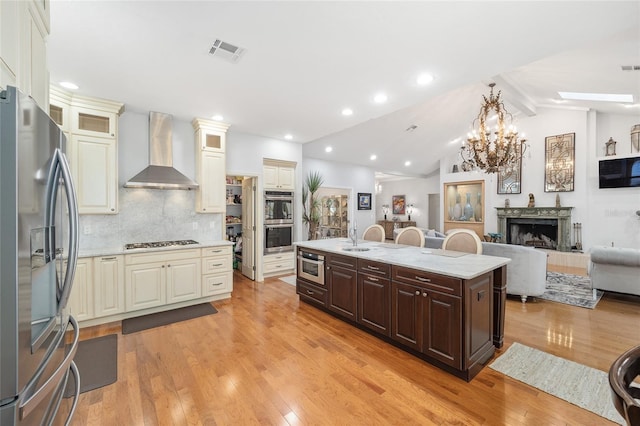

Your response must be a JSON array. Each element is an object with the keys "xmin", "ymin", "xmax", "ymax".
[{"xmin": 294, "ymin": 238, "xmax": 511, "ymax": 280}]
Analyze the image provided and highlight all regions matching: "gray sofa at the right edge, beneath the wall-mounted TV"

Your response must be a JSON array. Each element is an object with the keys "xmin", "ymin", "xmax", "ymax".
[{"xmin": 589, "ymin": 247, "xmax": 640, "ymax": 296}]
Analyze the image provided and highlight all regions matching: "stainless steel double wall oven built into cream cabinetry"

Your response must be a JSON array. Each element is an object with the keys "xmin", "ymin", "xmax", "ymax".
[{"xmin": 264, "ymin": 191, "xmax": 294, "ymax": 254}]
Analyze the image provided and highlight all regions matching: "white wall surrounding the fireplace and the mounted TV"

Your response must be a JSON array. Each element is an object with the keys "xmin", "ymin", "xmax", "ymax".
[{"xmin": 440, "ymin": 108, "xmax": 640, "ymax": 251}]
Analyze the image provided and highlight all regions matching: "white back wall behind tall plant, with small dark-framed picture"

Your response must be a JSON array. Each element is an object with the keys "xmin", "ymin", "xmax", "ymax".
[{"xmin": 300, "ymin": 158, "xmax": 376, "ymax": 240}]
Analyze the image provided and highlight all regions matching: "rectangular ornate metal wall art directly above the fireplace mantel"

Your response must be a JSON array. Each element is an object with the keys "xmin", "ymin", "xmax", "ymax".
[{"xmin": 544, "ymin": 133, "xmax": 576, "ymax": 192}]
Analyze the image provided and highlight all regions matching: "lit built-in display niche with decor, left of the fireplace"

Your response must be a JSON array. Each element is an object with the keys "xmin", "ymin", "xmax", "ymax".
[{"xmin": 443, "ymin": 180, "xmax": 485, "ymax": 239}]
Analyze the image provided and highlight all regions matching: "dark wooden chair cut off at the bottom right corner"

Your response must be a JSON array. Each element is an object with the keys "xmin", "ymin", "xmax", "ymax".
[{"xmin": 609, "ymin": 346, "xmax": 640, "ymax": 426}]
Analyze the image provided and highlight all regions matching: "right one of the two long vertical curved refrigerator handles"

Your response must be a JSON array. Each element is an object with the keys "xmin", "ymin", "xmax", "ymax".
[{"xmin": 56, "ymin": 149, "xmax": 79, "ymax": 309}]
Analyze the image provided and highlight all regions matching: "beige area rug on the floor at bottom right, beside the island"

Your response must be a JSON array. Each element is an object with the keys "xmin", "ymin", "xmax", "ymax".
[{"xmin": 489, "ymin": 342, "xmax": 625, "ymax": 425}]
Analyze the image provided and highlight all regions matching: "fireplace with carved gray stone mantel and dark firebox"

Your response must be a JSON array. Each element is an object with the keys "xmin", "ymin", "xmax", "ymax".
[{"xmin": 496, "ymin": 207, "xmax": 573, "ymax": 251}]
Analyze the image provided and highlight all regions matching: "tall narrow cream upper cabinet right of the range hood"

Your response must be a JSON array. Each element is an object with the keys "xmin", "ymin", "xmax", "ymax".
[{"xmin": 191, "ymin": 118, "xmax": 229, "ymax": 213}]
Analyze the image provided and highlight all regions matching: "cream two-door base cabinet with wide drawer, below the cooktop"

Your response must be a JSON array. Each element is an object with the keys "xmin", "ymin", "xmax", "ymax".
[{"xmin": 125, "ymin": 249, "xmax": 202, "ymax": 311}]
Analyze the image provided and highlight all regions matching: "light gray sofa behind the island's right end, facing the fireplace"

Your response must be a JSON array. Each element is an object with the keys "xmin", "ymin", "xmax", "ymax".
[{"xmin": 425, "ymin": 236, "xmax": 547, "ymax": 303}]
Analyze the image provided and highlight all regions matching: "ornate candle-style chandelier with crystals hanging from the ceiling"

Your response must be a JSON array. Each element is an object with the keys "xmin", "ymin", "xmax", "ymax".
[{"xmin": 460, "ymin": 83, "xmax": 527, "ymax": 173}]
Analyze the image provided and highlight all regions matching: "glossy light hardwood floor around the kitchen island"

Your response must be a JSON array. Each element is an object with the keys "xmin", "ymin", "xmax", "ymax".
[{"xmin": 73, "ymin": 271, "xmax": 640, "ymax": 425}]
